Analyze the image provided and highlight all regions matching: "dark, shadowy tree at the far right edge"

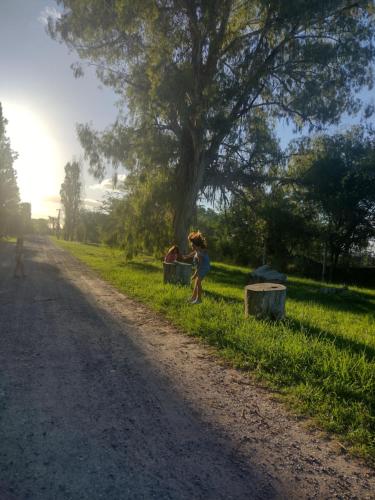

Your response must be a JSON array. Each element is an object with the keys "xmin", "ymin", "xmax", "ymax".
[{"xmin": 289, "ymin": 127, "xmax": 375, "ymax": 278}]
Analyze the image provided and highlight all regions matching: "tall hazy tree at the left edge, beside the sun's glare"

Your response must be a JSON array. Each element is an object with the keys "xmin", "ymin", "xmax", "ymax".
[{"xmin": 0, "ymin": 103, "xmax": 19, "ymax": 236}]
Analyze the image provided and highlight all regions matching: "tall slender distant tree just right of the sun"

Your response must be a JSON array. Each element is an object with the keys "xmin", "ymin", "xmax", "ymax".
[{"xmin": 60, "ymin": 161, "xmax": 82, "ymax": 240}]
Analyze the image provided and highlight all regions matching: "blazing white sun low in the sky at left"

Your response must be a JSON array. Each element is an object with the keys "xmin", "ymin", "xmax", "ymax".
[{"xmin": 2, "ymin": 101, "xmax": 63, "ymax": 217}]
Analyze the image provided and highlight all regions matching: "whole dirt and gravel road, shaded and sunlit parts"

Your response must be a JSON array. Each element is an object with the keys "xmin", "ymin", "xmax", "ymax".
[{"xmin": 0, "ymin": 238, "xmax": 375, "ymax": 500}]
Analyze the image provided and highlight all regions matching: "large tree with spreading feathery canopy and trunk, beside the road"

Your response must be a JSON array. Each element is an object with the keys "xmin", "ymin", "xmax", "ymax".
[{"xmin": 49, "ymin": 0, "xmax": 375, "ymax": 250}]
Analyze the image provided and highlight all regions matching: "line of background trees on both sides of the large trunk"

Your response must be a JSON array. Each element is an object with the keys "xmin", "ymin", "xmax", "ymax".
[{"xmin": 62, "ymin": 127, "xmax": 375, "ymax": 281}]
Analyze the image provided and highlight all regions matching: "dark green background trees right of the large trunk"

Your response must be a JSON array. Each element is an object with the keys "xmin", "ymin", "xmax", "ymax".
[{"xmin": 198, "ymin": 127, "xmax": 375, "ymax": 279}]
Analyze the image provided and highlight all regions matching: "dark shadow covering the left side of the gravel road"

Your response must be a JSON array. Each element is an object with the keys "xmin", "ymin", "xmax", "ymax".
[{"xmin": 0, "ymin": 239, "xmax": 280, "ymax": 499}]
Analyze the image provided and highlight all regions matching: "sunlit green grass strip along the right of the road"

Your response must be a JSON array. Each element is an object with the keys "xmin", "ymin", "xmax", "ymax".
[{"xmin": 55, "ymin": 240, "xmax": 375, "ymax": 462}]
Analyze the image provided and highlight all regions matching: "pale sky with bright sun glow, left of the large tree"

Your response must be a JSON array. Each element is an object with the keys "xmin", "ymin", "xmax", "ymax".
[{"xmin": 0, "ymin": 0, "xmax": 375, "ymax": 218}]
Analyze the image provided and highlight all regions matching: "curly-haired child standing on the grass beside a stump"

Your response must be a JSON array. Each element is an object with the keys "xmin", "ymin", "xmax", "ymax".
[{"xmin": 188, "ymin": 231, "xmax": 210, "ymax": 304}]
